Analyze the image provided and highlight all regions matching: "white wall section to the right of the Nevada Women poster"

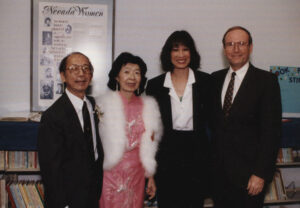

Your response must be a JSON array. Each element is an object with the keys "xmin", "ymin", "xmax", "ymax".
[{"xmin": 115, "ymin": 0, "xmax": 300, "ymax": 77}]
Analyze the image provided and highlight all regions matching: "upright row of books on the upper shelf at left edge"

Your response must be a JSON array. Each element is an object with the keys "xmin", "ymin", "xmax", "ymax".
[{"xmin": 0, "ymin": 151, "xmax": 39, "ymax": 170}]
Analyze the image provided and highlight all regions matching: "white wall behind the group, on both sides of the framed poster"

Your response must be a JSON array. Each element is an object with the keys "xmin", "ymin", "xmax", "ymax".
[{"xmin": 0, "ymin": 0, "xmax": 300, "ymax": 116}]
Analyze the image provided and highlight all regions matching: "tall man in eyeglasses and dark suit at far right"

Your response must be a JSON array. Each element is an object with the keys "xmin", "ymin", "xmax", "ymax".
[{"xmin": 212, "ymin": 26, "xmax": 281, "ymax": 208}]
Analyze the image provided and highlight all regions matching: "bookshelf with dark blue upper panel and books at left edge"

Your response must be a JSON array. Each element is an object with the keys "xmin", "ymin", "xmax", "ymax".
[{"xmin": 0, "ymin": 121, "xmax": 44, "ymax": 208}]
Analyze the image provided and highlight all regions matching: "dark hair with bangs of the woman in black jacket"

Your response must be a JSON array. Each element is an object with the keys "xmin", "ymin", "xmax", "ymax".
[{"xmin": 160, "ymin": 30, "xmax": 201, "ymax": 71}]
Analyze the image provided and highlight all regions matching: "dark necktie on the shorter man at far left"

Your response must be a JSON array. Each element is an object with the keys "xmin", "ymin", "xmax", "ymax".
[{"xmin": 82, "ymin": 101, "xmax": 95, "ymax": 160}]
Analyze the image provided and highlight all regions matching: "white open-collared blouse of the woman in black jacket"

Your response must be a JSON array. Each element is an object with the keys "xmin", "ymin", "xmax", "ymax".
[{"xmin": 164, "ymin": 69, "xmax": 195, "ymax": 131}]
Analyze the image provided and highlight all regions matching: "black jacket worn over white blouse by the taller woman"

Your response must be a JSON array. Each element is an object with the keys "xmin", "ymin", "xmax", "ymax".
[{"xmin": 146, "ymin": 71, "xmax": 213, "ymax": 194}]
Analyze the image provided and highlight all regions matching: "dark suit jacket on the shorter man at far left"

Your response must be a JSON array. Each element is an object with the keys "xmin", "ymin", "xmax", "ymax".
[{"xmin": 38, "ymin": 94, "xmax": 103, "ymax": 208}]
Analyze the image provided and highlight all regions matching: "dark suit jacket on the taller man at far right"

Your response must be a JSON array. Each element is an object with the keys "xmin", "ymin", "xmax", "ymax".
[{"xmin": 212, "ymin": 64, "xmax": 281, "ymax": 188}]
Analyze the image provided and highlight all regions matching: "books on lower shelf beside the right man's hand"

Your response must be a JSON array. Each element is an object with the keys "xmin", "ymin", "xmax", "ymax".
[{"xmin": 265, "ymin": 170, "xmax": 287, "ymax": 202}]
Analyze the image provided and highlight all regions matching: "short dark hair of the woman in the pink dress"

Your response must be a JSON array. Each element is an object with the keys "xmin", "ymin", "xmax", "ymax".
[{"xmin": 107, "ymin": 52, "xmax": 147, "ymax": 95}]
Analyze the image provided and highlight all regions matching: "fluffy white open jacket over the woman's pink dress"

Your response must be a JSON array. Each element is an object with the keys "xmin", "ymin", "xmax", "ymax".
[{"xmin": 96, "ymin": 91, "xmax": 163, "ymax": 177}]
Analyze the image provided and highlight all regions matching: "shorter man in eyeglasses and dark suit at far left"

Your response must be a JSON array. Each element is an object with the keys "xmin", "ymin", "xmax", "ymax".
[{"xmin": 38, "ymin": 52, "xmax": 103, "ymax": 208}]
